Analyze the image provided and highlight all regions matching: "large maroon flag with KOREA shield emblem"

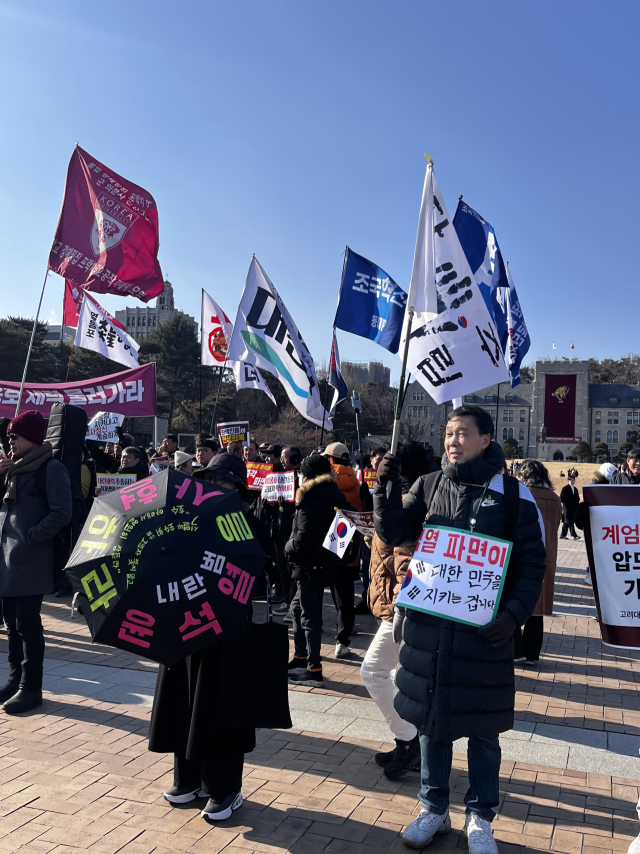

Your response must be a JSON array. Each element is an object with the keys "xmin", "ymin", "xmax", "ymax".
[{"xmin": 49, "ymin": 146, "xmax": 164, "ymax": 302}]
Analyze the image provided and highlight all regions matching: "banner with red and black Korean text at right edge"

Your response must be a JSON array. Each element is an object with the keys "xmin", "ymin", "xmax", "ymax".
[{"xmin": 582, "ymin": 484, "xmax": 640, "ymax": 649}]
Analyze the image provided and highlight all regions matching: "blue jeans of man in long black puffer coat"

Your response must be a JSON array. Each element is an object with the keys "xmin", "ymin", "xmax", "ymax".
[{"xmin": 418, "ymin": 735, "xmax": 502, "ymax": 821}]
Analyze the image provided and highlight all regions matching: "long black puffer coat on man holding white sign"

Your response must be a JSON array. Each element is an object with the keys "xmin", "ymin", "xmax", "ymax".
[{"xmin": 373, "ymin": 442, "xmax": 546, "ymax": 743}]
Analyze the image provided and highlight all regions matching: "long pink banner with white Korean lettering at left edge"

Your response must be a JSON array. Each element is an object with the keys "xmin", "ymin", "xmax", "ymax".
[{"xmin": 0, "ymin": 362, "xmax": 156, "ymax": 419}]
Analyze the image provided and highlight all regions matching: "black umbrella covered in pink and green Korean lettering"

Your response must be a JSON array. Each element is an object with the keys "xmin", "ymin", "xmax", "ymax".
[{"xmin": 66, "ymin": 469, "xmax": 267, "ymax": 665}]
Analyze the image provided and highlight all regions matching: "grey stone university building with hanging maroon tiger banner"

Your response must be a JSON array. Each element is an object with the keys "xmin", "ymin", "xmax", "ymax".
[{"xmin": 402, "ymin": 359, "xmax": 640, "ymax": 460}]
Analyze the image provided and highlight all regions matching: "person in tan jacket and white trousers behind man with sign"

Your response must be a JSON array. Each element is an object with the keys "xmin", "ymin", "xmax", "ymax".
[{"xmin": 360, "ymin": 442, "xmax": 432, "ymax": 780}]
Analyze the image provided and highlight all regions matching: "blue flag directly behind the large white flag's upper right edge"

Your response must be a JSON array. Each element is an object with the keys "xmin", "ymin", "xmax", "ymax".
[{"xmin": 453, "ymin": 201, "xmax": 509, "ymax": 354}]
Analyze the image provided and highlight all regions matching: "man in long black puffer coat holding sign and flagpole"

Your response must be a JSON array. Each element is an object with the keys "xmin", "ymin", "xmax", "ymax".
[{"xmin": 373, "ymin": 406, "xmax": 545, "ymax": 854}]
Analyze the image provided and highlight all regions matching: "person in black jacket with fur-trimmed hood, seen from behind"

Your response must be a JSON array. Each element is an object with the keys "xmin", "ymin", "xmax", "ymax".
[{"xmin": 285, "ymin": 454, "xmax": 349, "ymax": 688}]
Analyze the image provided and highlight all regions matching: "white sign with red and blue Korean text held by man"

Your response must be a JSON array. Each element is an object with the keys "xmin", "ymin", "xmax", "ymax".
[{"xmin": 396, "ymin": 525, "xmax": 512, "ymax": 626}]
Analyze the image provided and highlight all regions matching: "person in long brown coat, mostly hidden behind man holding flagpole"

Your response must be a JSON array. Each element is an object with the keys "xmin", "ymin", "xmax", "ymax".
[{"xmin": 513, "ymin": 460, "xmax": 562, "ymax": 664}]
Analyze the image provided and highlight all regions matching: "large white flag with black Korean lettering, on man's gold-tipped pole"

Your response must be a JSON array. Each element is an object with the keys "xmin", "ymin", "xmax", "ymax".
[{"xmin": 399, "ymin": 169, "xmax": 509, "ymax": 403}]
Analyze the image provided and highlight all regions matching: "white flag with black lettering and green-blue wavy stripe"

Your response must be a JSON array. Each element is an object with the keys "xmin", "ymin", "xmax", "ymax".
[{"xmin": 229, "ymin": 257, "xmax": 333, "ymax": 430}]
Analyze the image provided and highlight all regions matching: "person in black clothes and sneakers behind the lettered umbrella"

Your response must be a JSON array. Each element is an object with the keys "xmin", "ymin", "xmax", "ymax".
[{"xmin": 149, "ymin": 454, "xmax": 278, "ymax": 822}]
